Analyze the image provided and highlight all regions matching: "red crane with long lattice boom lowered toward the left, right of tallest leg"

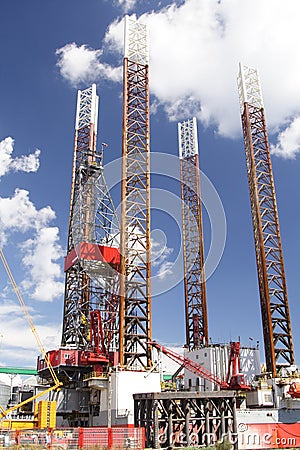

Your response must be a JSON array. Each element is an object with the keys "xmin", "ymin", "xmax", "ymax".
[{"xmin": 151, "ymin": 341, "xmax": 251, "ymax": 391}]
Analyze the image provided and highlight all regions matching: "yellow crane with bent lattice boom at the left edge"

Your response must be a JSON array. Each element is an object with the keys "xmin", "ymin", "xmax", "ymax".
[{"xmin": 0, "ymin": 247, "xmax": 62, "ymax": 419}]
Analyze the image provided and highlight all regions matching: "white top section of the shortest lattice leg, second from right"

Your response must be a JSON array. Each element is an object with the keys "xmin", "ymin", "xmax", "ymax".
[{"xmin": 178, "ymin": 117, "xmax": 198, "ymax": 159}]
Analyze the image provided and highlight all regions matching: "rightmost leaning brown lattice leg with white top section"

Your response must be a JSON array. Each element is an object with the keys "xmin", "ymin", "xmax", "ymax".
[{"xmin": 238, "ymin": 64, "xmax": 295, "ymax": 376}]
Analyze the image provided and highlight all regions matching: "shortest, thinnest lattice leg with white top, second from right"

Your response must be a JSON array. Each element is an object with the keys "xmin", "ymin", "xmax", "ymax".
[{"xmin": 178, "ymin": 118, "xmax": 208, "ymax": 350}]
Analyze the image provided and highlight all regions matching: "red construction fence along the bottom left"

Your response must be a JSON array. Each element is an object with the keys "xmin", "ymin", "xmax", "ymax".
[{"xmin": 0, "ymin": 427, "xmax": 145, "ymax": 450}]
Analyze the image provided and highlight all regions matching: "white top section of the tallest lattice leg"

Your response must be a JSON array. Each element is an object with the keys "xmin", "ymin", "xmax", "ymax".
[{"xmin": 124, "ymin": 16, "xmax": 149, "ymax": 65}]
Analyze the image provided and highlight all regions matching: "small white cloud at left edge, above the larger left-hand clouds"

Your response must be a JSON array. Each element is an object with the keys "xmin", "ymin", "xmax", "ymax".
[{"xmin": 0, "ymin": 137, "xmax": 40, "ymax": 176}]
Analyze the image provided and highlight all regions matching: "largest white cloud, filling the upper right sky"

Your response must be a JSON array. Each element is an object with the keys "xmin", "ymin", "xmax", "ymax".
[{"xmin": 95, "ymin": 0, "xmax": 300, "ymax": 155}]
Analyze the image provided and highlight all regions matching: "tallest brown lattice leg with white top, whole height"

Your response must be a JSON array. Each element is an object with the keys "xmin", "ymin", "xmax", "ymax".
[{"xmin": 120, "ymin": 16, "xmax": 152, "ymax": 369}]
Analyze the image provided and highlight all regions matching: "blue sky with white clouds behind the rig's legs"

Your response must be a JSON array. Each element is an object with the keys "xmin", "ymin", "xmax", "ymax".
[{"xmin": 0, "ymin": 0, "xmax": 300, "ymax": 366}]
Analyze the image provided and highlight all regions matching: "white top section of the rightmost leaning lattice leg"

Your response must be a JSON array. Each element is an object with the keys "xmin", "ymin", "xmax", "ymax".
[{"xmin": 237, "ymin": 63, "xmax": 264, "ymax": 114}]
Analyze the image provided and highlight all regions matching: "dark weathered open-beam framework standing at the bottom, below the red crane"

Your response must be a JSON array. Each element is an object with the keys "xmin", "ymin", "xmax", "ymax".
[{"xmin": 134, "ymin": 391, "xmax": 238, "ymax": 449}]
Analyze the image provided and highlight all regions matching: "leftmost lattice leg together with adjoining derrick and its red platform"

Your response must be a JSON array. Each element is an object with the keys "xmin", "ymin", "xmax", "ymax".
[{"xmin": 62, "ymin": 84, "xmax": 119, "ymax": 355}]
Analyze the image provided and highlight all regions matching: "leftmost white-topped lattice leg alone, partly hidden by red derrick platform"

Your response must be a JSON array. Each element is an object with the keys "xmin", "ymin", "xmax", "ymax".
[{"xmin": 62, "ymin": 84, "xmax": 98, "ymax": 349}]
